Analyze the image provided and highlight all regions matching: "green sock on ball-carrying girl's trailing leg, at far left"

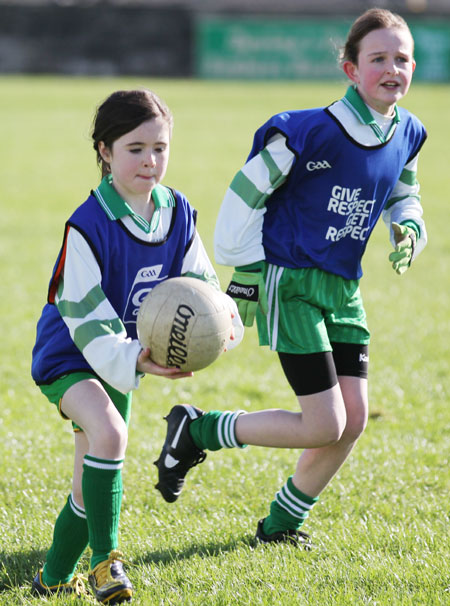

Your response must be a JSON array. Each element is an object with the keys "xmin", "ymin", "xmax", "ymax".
[{"xmin": 42, "ymin": 495, "xmax": 88, "ymax": 587}]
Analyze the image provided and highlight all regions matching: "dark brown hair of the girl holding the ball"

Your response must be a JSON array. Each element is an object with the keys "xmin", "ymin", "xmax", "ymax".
[{"xmin": 92, "ymin": 89, "xmax": 173, "ymax": 177}]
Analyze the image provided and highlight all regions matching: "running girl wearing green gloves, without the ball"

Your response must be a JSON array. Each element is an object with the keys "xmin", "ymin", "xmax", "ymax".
[{"xmin": 157, "ymin": 9, "xmax": 426, "ymax": 547}]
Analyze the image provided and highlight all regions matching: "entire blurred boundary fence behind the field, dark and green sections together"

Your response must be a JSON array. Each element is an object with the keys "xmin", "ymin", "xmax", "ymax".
[{"xmin": 0, "ymin": 0, "xmax": 450, "ymax": 81}]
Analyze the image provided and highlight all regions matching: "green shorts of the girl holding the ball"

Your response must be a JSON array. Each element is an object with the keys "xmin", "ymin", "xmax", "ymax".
[{"xmin": 39, "ymin": 372, "xmax": 133, "ymax": 431}]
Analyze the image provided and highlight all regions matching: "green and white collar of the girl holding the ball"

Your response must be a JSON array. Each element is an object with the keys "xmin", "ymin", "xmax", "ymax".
[{"xmin": 94, "ymin": 175, "xmax": 175, "ymax": 233}]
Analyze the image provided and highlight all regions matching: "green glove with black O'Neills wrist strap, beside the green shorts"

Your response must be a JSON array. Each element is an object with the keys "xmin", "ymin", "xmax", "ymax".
[{"xmin": 227, "ymin": 263, "xmax": 268, "ymax": 326}]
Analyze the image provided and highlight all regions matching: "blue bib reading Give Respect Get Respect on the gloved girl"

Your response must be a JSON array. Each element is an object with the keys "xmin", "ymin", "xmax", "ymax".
[{"xmin": 249, "ymin": 108, "xmax": 426, "ymax": 279}]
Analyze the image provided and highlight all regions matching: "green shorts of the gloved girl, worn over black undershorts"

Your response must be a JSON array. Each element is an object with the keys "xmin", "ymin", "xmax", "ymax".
[{"xmin": 256, "ymin": 263, "xmax": 370, "ymax": 354}]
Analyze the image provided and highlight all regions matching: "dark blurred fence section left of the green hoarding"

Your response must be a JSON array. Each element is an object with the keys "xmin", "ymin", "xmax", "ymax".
[{"xmin": 0, "ymin": 4, "xmax": 193, "ymax": 76}]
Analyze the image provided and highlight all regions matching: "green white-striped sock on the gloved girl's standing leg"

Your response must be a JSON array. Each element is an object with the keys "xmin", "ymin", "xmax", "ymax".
[{"xmin": 263, "ymin": 476, "xmax": 319, "ymax": 534}]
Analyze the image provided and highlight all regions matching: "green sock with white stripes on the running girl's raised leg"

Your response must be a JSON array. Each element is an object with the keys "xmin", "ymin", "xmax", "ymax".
[{"xmin": 189, "ymin": 410, "xmax": 246, "ymax": 450}]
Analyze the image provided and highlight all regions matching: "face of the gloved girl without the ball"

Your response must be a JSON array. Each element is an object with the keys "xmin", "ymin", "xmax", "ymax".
[{"xmin": 343, "ymin": 28, "xmax": 416, "ymax": 116}]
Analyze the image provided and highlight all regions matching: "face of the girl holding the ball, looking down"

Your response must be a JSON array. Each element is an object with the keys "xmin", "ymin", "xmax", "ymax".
[{"xmin": 99, "ymin": 116, "xmax": 170, "ymax": 202}]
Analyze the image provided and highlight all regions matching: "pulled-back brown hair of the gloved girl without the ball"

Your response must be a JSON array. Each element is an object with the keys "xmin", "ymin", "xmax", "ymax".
[{"xmin": 340, "ymin": 8, "xmax": 414, "ymax": 65}]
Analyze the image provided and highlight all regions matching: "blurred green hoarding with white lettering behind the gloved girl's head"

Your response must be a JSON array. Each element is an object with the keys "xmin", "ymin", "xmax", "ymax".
[{"xmin": 196, "ymin": 16, "xmax": 450, "ymax": 82}]
